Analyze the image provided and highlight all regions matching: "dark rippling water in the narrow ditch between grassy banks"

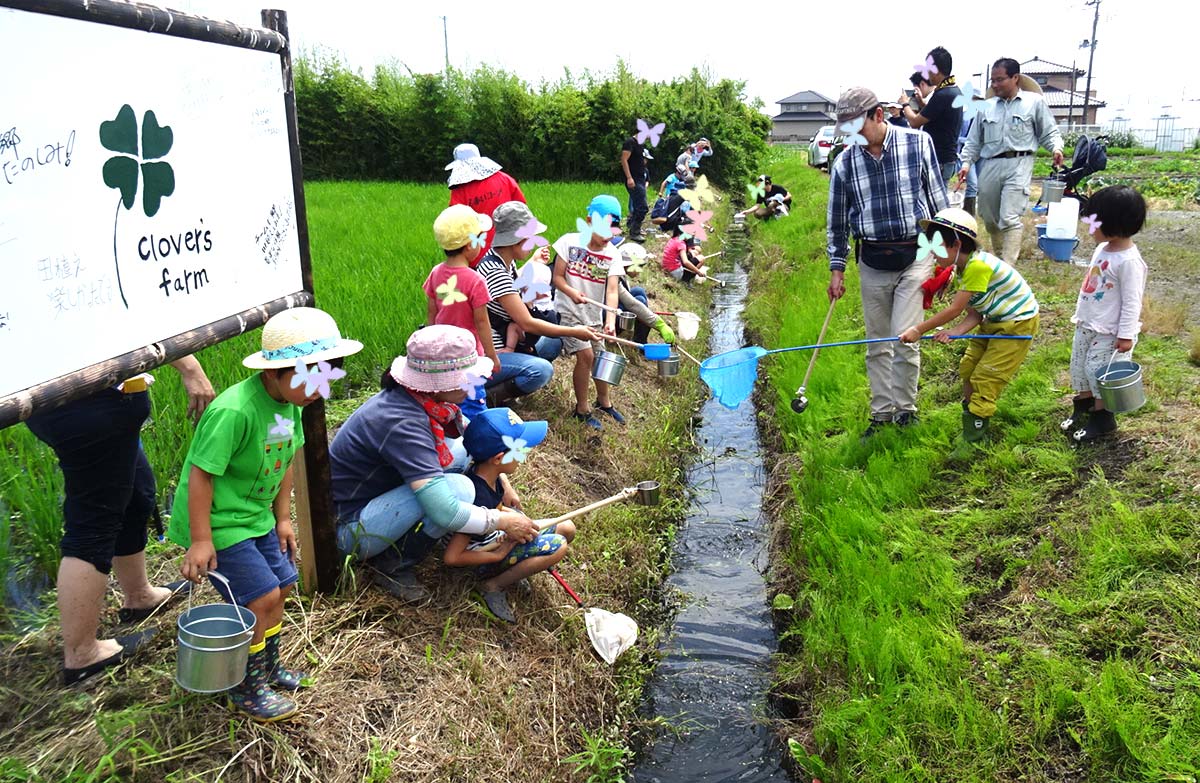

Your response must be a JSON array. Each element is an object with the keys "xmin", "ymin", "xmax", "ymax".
[{"xmin": 632, "ymin": 232, "xmax": 790, "ymax": 783}]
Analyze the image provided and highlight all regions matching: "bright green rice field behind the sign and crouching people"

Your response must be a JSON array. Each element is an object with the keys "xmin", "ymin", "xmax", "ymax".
[{"xmin": 0, "ymin": 183, "xmax": 626, "ymax": 604}]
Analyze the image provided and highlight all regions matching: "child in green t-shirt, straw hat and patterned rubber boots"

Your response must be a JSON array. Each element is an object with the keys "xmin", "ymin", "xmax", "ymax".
[{"xmin": 168, "ymin": 307, "xmax": 362, "ymax": 722}]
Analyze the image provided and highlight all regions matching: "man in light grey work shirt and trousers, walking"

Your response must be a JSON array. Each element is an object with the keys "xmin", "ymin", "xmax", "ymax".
[{"xmin": 955, "ymin": 58, "xmax": 1062, "ymax": 264}]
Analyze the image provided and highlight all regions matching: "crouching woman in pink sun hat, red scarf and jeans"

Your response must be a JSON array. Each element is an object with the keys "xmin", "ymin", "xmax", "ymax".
[{"xmin": 329, "ymin": 324, "xmax": 536, "ymax": 603}]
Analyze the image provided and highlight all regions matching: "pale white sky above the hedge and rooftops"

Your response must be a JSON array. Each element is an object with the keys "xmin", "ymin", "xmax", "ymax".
[{"xmin": 180, "ymin": 0, "xmax": 1200, "ymax": 127}]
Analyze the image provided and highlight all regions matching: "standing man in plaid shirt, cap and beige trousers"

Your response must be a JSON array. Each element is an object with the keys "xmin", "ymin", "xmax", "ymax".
[{"xmin": 828, "ymin": 86, "xmax": 948, "ymax": 437}]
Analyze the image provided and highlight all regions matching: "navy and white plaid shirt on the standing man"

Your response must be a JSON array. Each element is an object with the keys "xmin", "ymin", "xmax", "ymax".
[{"xmin": 827, "ymin": 125, "xmax": 947, "ymax": 270}]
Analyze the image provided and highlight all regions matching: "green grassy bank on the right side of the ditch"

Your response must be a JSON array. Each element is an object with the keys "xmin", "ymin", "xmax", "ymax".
[{"xmin": 748, "ymin": 148, "xmax": 1200, "ymax": 783}]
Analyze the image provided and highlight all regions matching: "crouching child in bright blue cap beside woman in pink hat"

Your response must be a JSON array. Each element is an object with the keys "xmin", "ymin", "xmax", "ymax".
[{"xmin": 443, "ymin": 408, "xmax": 575, "ymax": 623}]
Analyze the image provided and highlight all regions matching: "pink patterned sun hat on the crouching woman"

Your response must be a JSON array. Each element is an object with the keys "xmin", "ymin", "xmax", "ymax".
[{"xmin": 389, "ymin": 324, "xmax": 492, "ymax": 393}]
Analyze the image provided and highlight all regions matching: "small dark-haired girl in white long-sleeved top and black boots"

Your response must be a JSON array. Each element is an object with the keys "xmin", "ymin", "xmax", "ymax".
[{"xmin": 1060, "ymin": 185, "xmax": 1147, "ymax": 443}]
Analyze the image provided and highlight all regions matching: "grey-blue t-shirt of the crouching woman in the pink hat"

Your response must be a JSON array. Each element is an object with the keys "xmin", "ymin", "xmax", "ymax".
[{"xmin": 329, "ymin": 388, "xmax": 443, "ymax": 522}]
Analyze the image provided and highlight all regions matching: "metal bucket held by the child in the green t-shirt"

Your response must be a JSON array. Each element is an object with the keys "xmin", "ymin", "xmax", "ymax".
[{"xmin": 175, "ymin": 572, "xmax": 254, "ymax": 693}]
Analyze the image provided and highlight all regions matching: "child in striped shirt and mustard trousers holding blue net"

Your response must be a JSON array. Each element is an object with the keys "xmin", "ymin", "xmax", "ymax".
[{"xmin": 900, "ymin": 208, "xmax": 1038, "ymax": 444}]
